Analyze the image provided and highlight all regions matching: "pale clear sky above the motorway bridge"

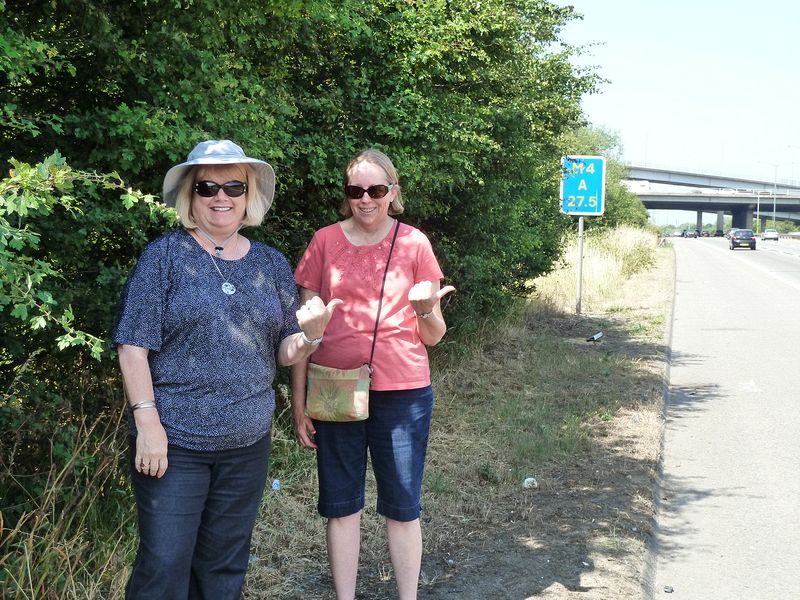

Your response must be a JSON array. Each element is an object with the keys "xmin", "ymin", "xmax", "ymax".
[{"xmin": 555, "ymin": 0, "xmax": 800, "ymax": 224}]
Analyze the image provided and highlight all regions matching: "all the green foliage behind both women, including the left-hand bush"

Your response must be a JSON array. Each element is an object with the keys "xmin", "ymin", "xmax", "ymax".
[{"xmin": 0, "ymin": 0, "xmax": 600, "ymax": 528}]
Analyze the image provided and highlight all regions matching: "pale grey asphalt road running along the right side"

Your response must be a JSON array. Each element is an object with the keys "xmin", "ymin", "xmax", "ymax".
[{"xmin": 650, "ymin": 238, "xmax": 800, "ymax": 600}]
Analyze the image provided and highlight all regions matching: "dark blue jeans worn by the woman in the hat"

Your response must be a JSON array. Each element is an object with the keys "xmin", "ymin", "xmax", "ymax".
[{"xmin": 125, "ymin": 435, "xmax": 270, "ymax": 600}]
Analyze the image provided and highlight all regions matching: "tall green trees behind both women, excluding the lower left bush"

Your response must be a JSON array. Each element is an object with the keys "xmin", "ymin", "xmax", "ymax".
[{"xmin": 2, "ymin": 0, "xmax": 594, "ymax": 310}]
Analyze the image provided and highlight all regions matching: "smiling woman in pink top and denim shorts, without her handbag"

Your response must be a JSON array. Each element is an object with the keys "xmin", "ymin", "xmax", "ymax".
[{"xmin": 292, "ymin": 150, "xmax": 455, "ymax": 600}]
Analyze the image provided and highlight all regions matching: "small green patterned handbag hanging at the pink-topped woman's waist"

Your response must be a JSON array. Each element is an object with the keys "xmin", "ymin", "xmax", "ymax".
[{"xmin": 306, "ymin": 363, "xmax": 371, "ymax": 421}]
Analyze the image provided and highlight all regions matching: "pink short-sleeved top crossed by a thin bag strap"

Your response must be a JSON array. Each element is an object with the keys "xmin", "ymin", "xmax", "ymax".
[{"xmin": 294, "ymin": 223, "xmax": 444, "ymax": 390}]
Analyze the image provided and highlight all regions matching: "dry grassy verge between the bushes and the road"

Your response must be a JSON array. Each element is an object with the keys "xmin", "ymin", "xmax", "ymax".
[{"xmin": 247, "ymin": 230, "xmax": 672, "ymax": 600}]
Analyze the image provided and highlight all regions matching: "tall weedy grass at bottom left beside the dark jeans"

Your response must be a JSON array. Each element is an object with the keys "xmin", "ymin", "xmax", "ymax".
[{"xmin": 0, "ymin": 417, "xmax": 135, "ymax": 600}]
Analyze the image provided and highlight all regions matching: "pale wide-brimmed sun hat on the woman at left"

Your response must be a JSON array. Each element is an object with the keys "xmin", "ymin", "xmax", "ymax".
[{"xmin": 162, "ymin": 140, "xmax": 275, "ymax": 214}]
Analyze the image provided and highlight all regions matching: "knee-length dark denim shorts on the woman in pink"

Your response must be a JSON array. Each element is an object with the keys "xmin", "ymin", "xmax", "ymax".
[{"xmin": 314, "ymin": 386, "xmax": 433, "ymax": 521}]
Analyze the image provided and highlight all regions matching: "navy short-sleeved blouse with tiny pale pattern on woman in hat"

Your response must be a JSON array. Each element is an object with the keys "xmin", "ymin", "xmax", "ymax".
[{"xmin": 114, "ymin": 229, "xmax": 300, "ymax": 450}]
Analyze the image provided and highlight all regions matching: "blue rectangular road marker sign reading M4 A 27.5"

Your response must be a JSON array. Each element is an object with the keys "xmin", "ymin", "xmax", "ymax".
[{"xmin": 561, "ymin": 156, "xmax": 606, "ymax": 217}]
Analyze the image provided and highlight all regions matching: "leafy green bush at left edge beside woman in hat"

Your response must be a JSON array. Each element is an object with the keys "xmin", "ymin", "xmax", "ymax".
[{"xmin": 0, "ymin": 153, "xmax": 175, "ymax": 523}]
